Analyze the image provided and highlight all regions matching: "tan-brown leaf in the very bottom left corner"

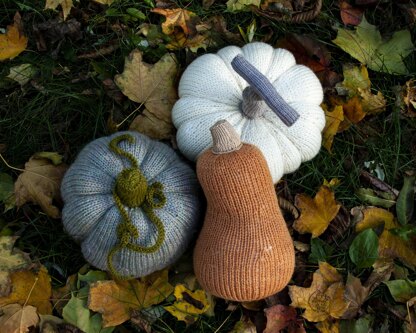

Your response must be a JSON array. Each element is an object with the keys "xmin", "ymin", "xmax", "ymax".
[{"xmin": 0, "ymin": 304, "xmax": 39, "ymax": 333}]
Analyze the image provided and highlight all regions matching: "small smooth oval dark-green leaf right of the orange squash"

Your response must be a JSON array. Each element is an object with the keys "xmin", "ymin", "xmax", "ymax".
[{"xmin": 349, "ymin": 229, "xmax": 378, "ymax": 268}]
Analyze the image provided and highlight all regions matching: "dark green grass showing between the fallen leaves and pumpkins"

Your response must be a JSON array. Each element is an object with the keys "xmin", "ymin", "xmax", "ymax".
[{"xmin": 0, "ymin": 0, "xmax": 416, "ymax": 332}]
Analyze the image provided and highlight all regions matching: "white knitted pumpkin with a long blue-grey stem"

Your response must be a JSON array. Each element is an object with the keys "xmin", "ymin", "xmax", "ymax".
[{"xmin": 172, "ymin": 43, "xmax": 325, "ymax": 183}]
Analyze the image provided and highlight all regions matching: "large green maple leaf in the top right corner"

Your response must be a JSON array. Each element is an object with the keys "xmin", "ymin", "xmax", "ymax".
[{"xmin": 333, "ymin": 16, "xmax": 414, "ymax": 74}]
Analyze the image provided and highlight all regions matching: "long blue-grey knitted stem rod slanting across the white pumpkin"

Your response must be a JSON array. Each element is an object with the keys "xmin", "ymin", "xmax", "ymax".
[{"xmin": 231, "ymin": 55, "xmax": 300, "ymax": 126}]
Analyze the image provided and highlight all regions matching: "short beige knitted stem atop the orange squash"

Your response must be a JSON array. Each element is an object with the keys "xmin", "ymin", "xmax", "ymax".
[{"xmin": 210, "ymin": 120, "xmax": 243, "ymax": 154}]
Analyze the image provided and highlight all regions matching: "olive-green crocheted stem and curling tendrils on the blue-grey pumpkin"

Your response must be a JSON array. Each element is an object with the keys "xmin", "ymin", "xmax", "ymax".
[{"xmin": 107, "ymin": 134, "xmax": 166, "ymax": 279}]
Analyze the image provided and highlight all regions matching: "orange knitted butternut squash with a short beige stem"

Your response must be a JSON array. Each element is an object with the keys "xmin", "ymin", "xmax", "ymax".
[{"xmin": 194, "ymin": 121, "xmax": 295, "ymax": 301}]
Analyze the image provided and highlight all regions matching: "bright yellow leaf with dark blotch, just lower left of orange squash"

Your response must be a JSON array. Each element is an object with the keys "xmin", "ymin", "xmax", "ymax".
[{"xmin": 164, "ymin": 284, "xmax": 210, "ymax": 324}]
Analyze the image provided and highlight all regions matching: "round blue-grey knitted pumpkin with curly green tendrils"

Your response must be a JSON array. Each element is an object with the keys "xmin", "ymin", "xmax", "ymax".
[{"xmin": 61, "ymin": 131, "xmax": 200, "ymax": 278}]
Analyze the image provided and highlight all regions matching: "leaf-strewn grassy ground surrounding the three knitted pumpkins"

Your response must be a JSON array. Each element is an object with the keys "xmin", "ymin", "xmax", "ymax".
[{"xmin": 0, "ymin": 0, "xmax": 416, "ymax": 333}]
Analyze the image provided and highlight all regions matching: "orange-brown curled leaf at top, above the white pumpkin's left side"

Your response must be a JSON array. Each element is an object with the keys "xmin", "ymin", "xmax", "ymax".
[{"xmin": 152, "ymin": 8, "xmax": 201, "ymax": 37}]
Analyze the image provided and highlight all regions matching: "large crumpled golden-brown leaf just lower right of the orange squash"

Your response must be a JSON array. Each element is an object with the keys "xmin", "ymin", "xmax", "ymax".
[{"xmin": 289, "ymin": 262, "xmax": 349, "ymax": 322}]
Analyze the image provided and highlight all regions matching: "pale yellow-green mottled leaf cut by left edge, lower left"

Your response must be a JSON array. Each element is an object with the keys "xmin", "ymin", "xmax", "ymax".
[{"xmin": 0, "ymin": 236, "xmax": 30, "ymax": 297}]
